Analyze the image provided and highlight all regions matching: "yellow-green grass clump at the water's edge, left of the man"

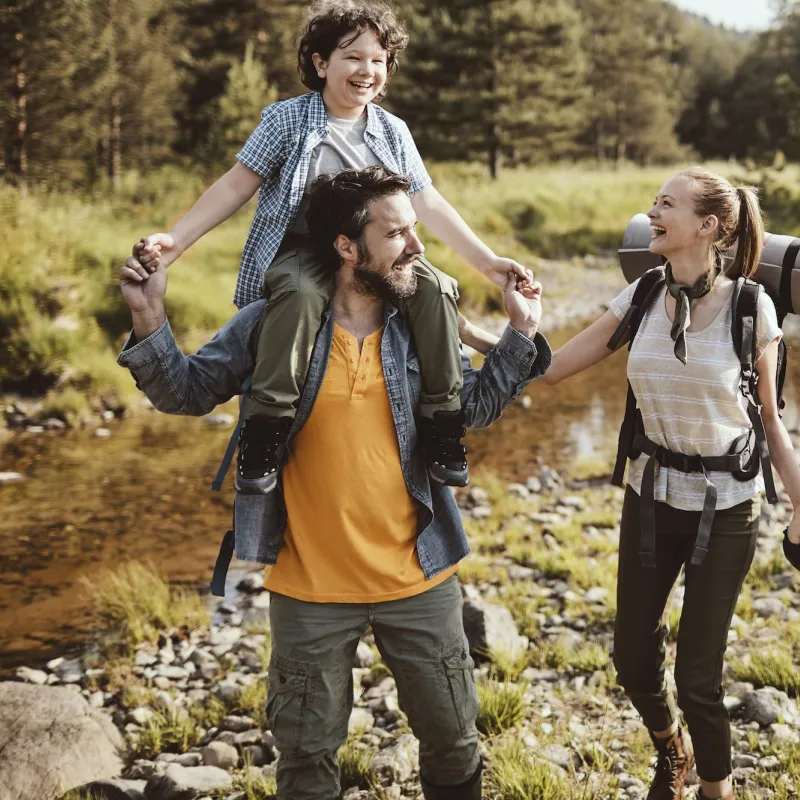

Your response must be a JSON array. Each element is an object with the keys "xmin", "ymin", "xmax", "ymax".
[{"xmin": 84, "ymin": 561, "xmax": 210, "ymax": 652}]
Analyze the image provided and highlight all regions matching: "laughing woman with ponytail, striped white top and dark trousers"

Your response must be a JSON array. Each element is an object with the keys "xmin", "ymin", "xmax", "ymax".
[{"xmin": 467, "ymin": 168, "xmax": 800, "ymax": 800}]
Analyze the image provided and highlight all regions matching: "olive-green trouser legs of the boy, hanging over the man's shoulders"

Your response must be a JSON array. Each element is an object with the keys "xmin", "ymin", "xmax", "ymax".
[{"xmin": 245, "ymin": 238, "xmax": 463, "ymax": 419}]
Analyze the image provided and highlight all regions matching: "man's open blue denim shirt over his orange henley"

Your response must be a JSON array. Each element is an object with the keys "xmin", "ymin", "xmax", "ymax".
[{"xmin": 118, "ymin": 300, "xmax": 552, "ymax": 578}]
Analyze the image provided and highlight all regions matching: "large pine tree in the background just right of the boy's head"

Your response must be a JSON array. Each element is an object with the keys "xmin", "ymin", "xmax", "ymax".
[{"xmin": 388, "ymin": 0, "xmax": 585, "ymax": 177}]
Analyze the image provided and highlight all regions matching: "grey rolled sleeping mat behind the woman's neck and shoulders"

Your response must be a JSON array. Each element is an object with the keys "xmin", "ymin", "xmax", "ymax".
[{"xmin": 618, "ymin": 214, "xmax": 800, "ymax": 314}]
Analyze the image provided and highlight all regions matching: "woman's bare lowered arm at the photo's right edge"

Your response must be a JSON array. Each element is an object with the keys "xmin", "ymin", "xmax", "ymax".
[{"xmin": 756, "ymin": 339, "xmax": 800, "ymax": 544}]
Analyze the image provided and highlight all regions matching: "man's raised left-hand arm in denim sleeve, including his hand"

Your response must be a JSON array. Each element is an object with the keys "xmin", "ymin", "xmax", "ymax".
[{"xmin": 118, "ymin": 259, "xmax": 263, "ymax": 416}]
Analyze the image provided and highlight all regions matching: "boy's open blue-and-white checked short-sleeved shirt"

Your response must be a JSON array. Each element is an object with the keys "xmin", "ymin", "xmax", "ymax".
[{"xmin": 233, "ymin": 92, "xmax": 431, "ymax": 308}]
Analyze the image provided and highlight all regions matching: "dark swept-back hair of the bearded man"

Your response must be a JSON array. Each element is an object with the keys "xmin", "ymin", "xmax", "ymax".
[{"xmin": 306, "ymin": 167, "xmax": 411, "ymax": 270}]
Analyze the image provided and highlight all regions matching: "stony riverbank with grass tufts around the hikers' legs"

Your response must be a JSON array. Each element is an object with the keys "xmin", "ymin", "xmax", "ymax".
[{"xmin": 6, "ymin": 467, "xmax": 800, "ymax": 800}]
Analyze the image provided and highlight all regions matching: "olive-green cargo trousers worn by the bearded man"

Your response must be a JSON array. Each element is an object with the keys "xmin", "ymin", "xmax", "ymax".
[{"xmin": 267, "ymin": 575, "xmax": 480, "ymax": 800}]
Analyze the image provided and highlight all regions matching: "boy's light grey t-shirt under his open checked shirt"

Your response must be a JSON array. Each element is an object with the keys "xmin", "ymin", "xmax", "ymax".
[{"xmin": 287, "ymin": 114, "xmax": 381, "ymax": 236}]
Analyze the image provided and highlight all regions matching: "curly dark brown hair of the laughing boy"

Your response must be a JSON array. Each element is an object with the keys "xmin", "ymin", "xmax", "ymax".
[{"xmin": 297, "ymin": 0, "xmax": 408, "ymax": 99}]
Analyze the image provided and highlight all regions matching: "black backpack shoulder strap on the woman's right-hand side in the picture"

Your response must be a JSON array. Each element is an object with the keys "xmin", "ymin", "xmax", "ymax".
[{"xmin": 731, "ymin": 278, "xmax": 778, "ymax": 503}]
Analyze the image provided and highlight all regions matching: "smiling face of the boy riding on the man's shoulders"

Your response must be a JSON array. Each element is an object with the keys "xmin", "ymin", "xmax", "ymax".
[{"xmin": 313, "ymin": 30, "xmax": 386, "ymax": 119}]
